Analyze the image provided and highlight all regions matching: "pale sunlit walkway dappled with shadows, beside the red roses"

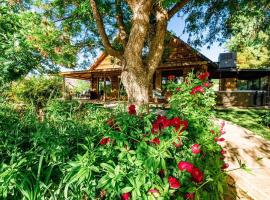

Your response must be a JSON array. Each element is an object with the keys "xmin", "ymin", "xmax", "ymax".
[{"xmin": 218, "ymin": 120, "xmax": 270, "ymax": 200}]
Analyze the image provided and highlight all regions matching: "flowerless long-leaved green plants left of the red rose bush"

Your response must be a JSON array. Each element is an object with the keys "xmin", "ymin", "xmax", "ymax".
[{"xmin": 0, "ymin": 101, "xmax": 109, "ymax": 200}]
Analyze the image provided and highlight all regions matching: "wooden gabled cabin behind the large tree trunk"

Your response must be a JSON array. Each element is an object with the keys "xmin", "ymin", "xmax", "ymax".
[{"xmin": 60, "ymin": 35, "xmax": 218, "ymax": 101}]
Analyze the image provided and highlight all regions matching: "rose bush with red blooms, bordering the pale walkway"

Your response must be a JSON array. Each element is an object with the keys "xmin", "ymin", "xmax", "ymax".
[{"xmin": 63, "ymin": 71, "xmax": 227, "ymax": 200}]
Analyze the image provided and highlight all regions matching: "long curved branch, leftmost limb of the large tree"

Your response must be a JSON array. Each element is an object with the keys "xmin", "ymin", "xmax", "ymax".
[{"xmin": 90, "ymin": 0, "xmax": 123, "ymax": 60}]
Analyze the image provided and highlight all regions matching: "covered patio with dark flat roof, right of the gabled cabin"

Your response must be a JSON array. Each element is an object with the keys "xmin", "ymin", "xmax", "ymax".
[{"xmin": 210, "ymin": 68, "xmax": 270, "ymax": 107}]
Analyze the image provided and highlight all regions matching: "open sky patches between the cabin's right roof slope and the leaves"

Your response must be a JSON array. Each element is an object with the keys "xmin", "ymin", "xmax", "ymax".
[{"xmin": 168, "ymin": 16, "xmax": 226, "ymax": 62}]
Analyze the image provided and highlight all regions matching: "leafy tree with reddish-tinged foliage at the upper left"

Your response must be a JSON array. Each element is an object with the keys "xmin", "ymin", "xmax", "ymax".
[{"xmin": 0, "ymin": 1, "xmax": 76, "ymax": 83}]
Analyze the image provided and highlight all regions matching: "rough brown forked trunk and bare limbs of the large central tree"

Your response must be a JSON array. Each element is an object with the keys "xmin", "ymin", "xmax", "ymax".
[{"xmin": 89, "ymin": 0, "xmax": 190, "ymax": 106}]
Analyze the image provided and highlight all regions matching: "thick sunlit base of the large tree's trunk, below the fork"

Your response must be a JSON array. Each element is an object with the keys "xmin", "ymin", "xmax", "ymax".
[{"xmin": 121, "ymin": 71, "xmax": 150, "ymax": 106}]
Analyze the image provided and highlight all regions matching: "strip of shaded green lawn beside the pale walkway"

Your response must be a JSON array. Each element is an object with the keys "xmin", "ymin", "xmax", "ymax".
[{"xmin": 216, "ymin": 108, "xmax": 270, "ymax": 140}]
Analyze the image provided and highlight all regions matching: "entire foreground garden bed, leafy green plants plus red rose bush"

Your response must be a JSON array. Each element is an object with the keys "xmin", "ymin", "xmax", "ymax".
[{"xmin": 0, "ymin": 73, "xmax": 228, "ymax": 200}]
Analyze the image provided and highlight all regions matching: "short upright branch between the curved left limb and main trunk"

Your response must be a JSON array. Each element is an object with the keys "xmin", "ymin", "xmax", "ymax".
[{"xmin": 115, "ymin": 0, "xmax": 127, "ymax": 47}]
